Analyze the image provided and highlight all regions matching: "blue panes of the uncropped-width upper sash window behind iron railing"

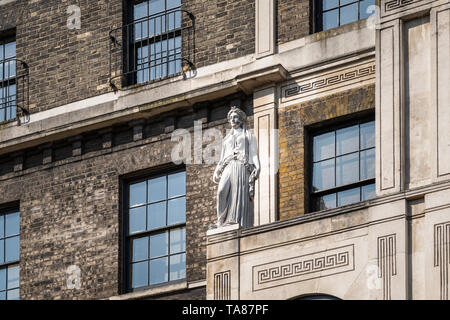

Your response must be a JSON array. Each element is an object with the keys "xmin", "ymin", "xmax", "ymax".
[{"xmin": 127, "ymin": 0, "xmax": 182, "ymax": 83}]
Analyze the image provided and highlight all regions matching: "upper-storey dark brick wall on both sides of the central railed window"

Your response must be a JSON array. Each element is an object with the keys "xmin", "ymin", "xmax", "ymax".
[{"xmin": 0, "ymin": 0, "xmax": 255, "ymax": 112}]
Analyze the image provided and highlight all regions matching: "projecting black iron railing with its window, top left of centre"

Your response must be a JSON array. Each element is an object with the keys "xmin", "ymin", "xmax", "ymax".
[{"xmin": 110, "ymin": 0, "xmax": 194, "ymax": 88}]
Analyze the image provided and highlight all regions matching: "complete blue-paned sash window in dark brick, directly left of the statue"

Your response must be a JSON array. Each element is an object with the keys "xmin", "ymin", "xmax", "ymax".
[{"xmin": 127, "ymin": 171, "xmax": 186, "ymax": 291}]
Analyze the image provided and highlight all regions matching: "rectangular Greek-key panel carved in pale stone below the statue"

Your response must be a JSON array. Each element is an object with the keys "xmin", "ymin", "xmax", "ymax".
[{"xmin": 252, "ymin": 244, "xmax": 355, "ymax": 292}]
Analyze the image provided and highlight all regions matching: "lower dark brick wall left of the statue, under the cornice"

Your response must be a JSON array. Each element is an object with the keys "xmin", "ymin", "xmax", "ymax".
[{"xmin": 0, "ymin": 96, "xmax": 253, "ymax": 299}]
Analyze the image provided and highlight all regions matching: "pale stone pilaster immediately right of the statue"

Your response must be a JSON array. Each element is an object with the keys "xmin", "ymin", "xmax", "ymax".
[{"xmin": 253, "ymin": 86, "xmax": 278, "ymax": 226}]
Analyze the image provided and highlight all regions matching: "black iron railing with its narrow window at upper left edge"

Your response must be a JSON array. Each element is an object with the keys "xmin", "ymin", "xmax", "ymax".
[{"xmin": 0, "ymin": 39, "xmax": 29, "ymax": 123}]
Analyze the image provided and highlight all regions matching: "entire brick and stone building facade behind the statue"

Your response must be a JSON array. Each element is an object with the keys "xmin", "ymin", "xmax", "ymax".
[{"xmin": 0, "ymin": 0, "xmax": 450, "ymax": 299}]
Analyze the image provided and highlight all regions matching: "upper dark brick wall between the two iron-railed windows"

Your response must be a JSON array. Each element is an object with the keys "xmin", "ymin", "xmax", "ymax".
[{"xmin": 0, "ymin": 0, "xmax": 122, "ymax": 112}]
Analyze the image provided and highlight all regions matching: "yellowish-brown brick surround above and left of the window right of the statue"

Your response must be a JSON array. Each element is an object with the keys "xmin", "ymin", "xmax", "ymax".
[{"xmin": 278, "ymin": 85, "xmax": 375, "ymax": 220}]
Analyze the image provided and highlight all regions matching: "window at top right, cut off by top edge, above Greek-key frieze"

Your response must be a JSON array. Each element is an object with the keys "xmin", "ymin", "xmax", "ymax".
[{"xmin": 315, "ymin": 0, "xmax": 375, "ymax": 31}]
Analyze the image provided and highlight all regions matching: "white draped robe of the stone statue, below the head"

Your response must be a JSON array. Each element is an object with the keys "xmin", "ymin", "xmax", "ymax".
[{"xmin": 217, "ymin": 127, "xmax": 257, "ymax": 228}]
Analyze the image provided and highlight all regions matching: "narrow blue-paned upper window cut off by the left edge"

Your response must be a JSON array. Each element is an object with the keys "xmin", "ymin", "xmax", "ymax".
[{"xmin": 0, "ymin": 39, "xmax": 17, "ymax": 122}]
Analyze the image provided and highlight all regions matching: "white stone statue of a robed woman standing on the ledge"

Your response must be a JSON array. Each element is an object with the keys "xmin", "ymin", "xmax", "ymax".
[{"xmin": 213, "ymin": 106, "xmax": 261, "ymax": 228}]
